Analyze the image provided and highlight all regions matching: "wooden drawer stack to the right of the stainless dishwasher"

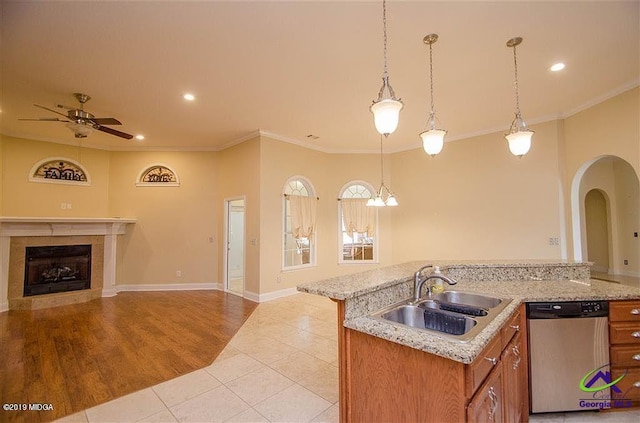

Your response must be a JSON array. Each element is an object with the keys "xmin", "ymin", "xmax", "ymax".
[{"xmin": 609, "ymin": 301, "xmax": 640, "ymax": 408}]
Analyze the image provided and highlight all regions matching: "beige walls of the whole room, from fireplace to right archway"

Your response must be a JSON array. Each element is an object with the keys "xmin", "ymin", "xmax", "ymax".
[{"xmin": 0, "ymin": 88, "xmax": 640, "ymax": 296}]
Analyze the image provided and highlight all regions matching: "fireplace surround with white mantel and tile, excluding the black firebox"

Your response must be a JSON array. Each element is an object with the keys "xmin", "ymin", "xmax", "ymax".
[{"xmin": 0, "ymin": 217, "xmax": 136, "ymax": 312}]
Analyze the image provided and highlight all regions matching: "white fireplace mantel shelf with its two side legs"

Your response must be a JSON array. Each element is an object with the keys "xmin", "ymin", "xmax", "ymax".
[{"xmin": 0, "ymin": 216, "xmax": 136, "ymax": 312}]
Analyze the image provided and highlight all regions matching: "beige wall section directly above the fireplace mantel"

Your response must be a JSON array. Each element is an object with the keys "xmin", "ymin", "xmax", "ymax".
[{"xmin": 2, "ymin": 136, "xmax": 109, "ymax": 217}]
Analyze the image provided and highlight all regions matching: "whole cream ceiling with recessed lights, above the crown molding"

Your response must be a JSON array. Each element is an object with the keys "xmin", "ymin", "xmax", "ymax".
[{"xmin": 0, "ymin": 0, "xmax": 640, "ymax": 152}]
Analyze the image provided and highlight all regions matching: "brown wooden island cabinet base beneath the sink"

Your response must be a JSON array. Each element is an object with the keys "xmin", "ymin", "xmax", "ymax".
[{"xmin": 339, "ymin": 306, "xmax": 529, "ymax": 423}]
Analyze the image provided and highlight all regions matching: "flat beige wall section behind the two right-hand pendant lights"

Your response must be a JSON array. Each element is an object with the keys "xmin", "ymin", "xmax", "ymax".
[{"xmin": 392, "ymin": 122, "xmax": 561, "ymax": 262}]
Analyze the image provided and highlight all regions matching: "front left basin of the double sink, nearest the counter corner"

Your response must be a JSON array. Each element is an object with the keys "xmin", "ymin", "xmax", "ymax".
[{"xmin": 380, "ymin": 305, "xmax": 477, "ymax": 335}]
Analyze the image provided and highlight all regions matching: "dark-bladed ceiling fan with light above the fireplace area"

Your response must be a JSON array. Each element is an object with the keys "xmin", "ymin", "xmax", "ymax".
[{"xmin": 19, "ymin": 93, "xmax": 133, "ymax": 140}]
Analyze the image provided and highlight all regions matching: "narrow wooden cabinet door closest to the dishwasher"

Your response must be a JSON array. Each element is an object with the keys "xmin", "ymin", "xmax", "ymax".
[{"xmin": 501, "ymin": 334, "xmax": 526, "ymax": 423}]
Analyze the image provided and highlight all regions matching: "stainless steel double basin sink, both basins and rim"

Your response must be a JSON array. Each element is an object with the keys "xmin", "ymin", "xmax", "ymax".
[{"xmin": 372, "ymin": 291, "xmax": 511, "ymax": 342}]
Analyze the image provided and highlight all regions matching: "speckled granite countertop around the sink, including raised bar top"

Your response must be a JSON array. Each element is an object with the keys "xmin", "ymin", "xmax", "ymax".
[{"xmin": 298, "ymin": 260, "xmax": 640, "ymax": 364}]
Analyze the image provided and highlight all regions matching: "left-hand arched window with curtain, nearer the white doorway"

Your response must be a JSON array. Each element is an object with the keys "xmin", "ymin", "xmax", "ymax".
[{"xmin": 282, "ymin": 176, "xmax": 317, "ymax": 270}]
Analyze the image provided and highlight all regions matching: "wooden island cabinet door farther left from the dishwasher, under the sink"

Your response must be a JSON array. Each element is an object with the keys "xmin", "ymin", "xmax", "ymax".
[{"xmin": 467, "ymin": 366, "xmax": 504, "ymax": 423}]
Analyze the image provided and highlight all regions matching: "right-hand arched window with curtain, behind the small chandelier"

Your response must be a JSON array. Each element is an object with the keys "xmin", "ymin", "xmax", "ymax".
[{"xmin": 338, "ymin": 181, "xmax": 378, "ymax": 263}]
